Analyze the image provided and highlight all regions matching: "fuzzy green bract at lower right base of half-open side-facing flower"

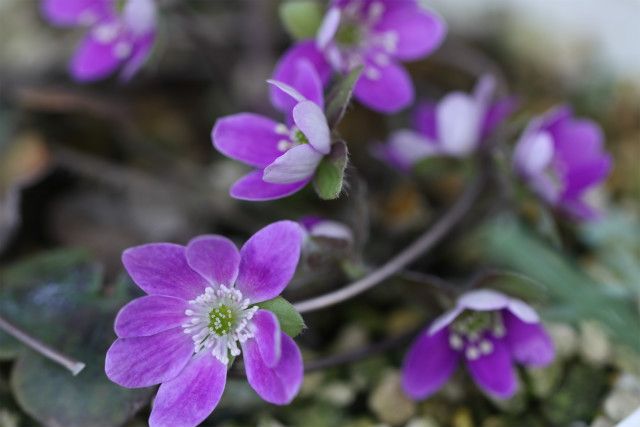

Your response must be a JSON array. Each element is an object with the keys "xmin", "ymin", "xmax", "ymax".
[{"xmin": 313, "ymin": 141, "xmax": 349, "ymax": 200}]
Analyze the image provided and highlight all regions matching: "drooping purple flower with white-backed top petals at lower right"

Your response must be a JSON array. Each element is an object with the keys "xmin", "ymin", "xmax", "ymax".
[{"xmin": 402, "ymin": 289, "xmax": 555, "ymax": 399}]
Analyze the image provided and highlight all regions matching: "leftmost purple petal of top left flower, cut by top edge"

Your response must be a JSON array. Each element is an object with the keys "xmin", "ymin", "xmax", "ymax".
[{"xmin": 41, "ymin": 0, "xmax": 115, "ymax": 26}]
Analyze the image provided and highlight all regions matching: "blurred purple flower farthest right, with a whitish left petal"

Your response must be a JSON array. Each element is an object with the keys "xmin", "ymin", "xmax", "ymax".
[{"xmin": 513, "ymin": 106, "xmax": 612, "ymax": 220}]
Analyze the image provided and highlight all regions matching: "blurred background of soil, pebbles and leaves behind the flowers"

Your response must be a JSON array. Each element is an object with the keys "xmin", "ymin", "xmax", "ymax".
[{"xmin": 0, "ymin": 0, "xmax": 640, "ymax": 427}]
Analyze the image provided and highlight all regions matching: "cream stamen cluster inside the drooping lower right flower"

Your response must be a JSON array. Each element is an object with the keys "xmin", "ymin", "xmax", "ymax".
[{"xmin": 449, "ymin": 311, "xmax": 506, "ymax": 360}]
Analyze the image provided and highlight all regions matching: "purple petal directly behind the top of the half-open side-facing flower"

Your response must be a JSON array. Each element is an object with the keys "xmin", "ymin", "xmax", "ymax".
[{"xmin": 271, "ymin": 40, "xmax": 332, "ymax": 111}]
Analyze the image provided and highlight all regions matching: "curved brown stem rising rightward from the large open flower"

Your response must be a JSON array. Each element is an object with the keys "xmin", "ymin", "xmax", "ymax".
[{"xmin": 294, "ymin": 175, "xmax": 484, "ymax": 313}]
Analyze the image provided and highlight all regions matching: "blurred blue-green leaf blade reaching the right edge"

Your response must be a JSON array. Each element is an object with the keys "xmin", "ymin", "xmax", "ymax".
[{"xmin": 482, "ymin": 220, "xmax": 640, "ymax": 351}]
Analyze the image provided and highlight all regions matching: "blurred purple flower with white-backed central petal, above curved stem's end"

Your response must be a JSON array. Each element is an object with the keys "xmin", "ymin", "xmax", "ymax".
[{"xmin": 374, "ymin": 75, "xmax": 516, "ymax": 171}]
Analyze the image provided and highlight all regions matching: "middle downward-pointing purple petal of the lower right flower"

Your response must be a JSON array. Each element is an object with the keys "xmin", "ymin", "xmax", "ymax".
[{"xmin": 467, "ymin": 340, "xmax": 518, "ymax": 399}]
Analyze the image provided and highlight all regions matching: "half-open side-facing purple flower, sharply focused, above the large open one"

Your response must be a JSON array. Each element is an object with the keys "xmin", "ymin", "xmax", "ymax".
[{"xmin": 211, "ymin": 61, "xmax": 331, "ymax": 201}]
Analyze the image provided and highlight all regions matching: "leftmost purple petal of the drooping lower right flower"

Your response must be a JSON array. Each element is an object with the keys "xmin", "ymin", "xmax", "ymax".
[{"xmin": 402, "ymin": 330, "xmax": 460, "ymax": 399}]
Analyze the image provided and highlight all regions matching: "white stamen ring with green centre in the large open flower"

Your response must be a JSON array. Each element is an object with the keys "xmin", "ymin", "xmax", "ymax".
[{"xmin": 182, "ymin": 285, "xmax": 258, "ymax": 364}]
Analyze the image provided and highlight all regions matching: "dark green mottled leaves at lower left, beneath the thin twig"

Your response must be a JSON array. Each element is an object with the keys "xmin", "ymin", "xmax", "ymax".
[{"xmin": 0, "ymin": 250, "xmax": 150, "ymax": 427}]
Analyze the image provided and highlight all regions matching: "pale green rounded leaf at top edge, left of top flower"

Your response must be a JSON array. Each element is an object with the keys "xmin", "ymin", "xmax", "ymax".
[{"xmin": 279, "ymin": 0, "xmax": 324, "ymax": 40}]
